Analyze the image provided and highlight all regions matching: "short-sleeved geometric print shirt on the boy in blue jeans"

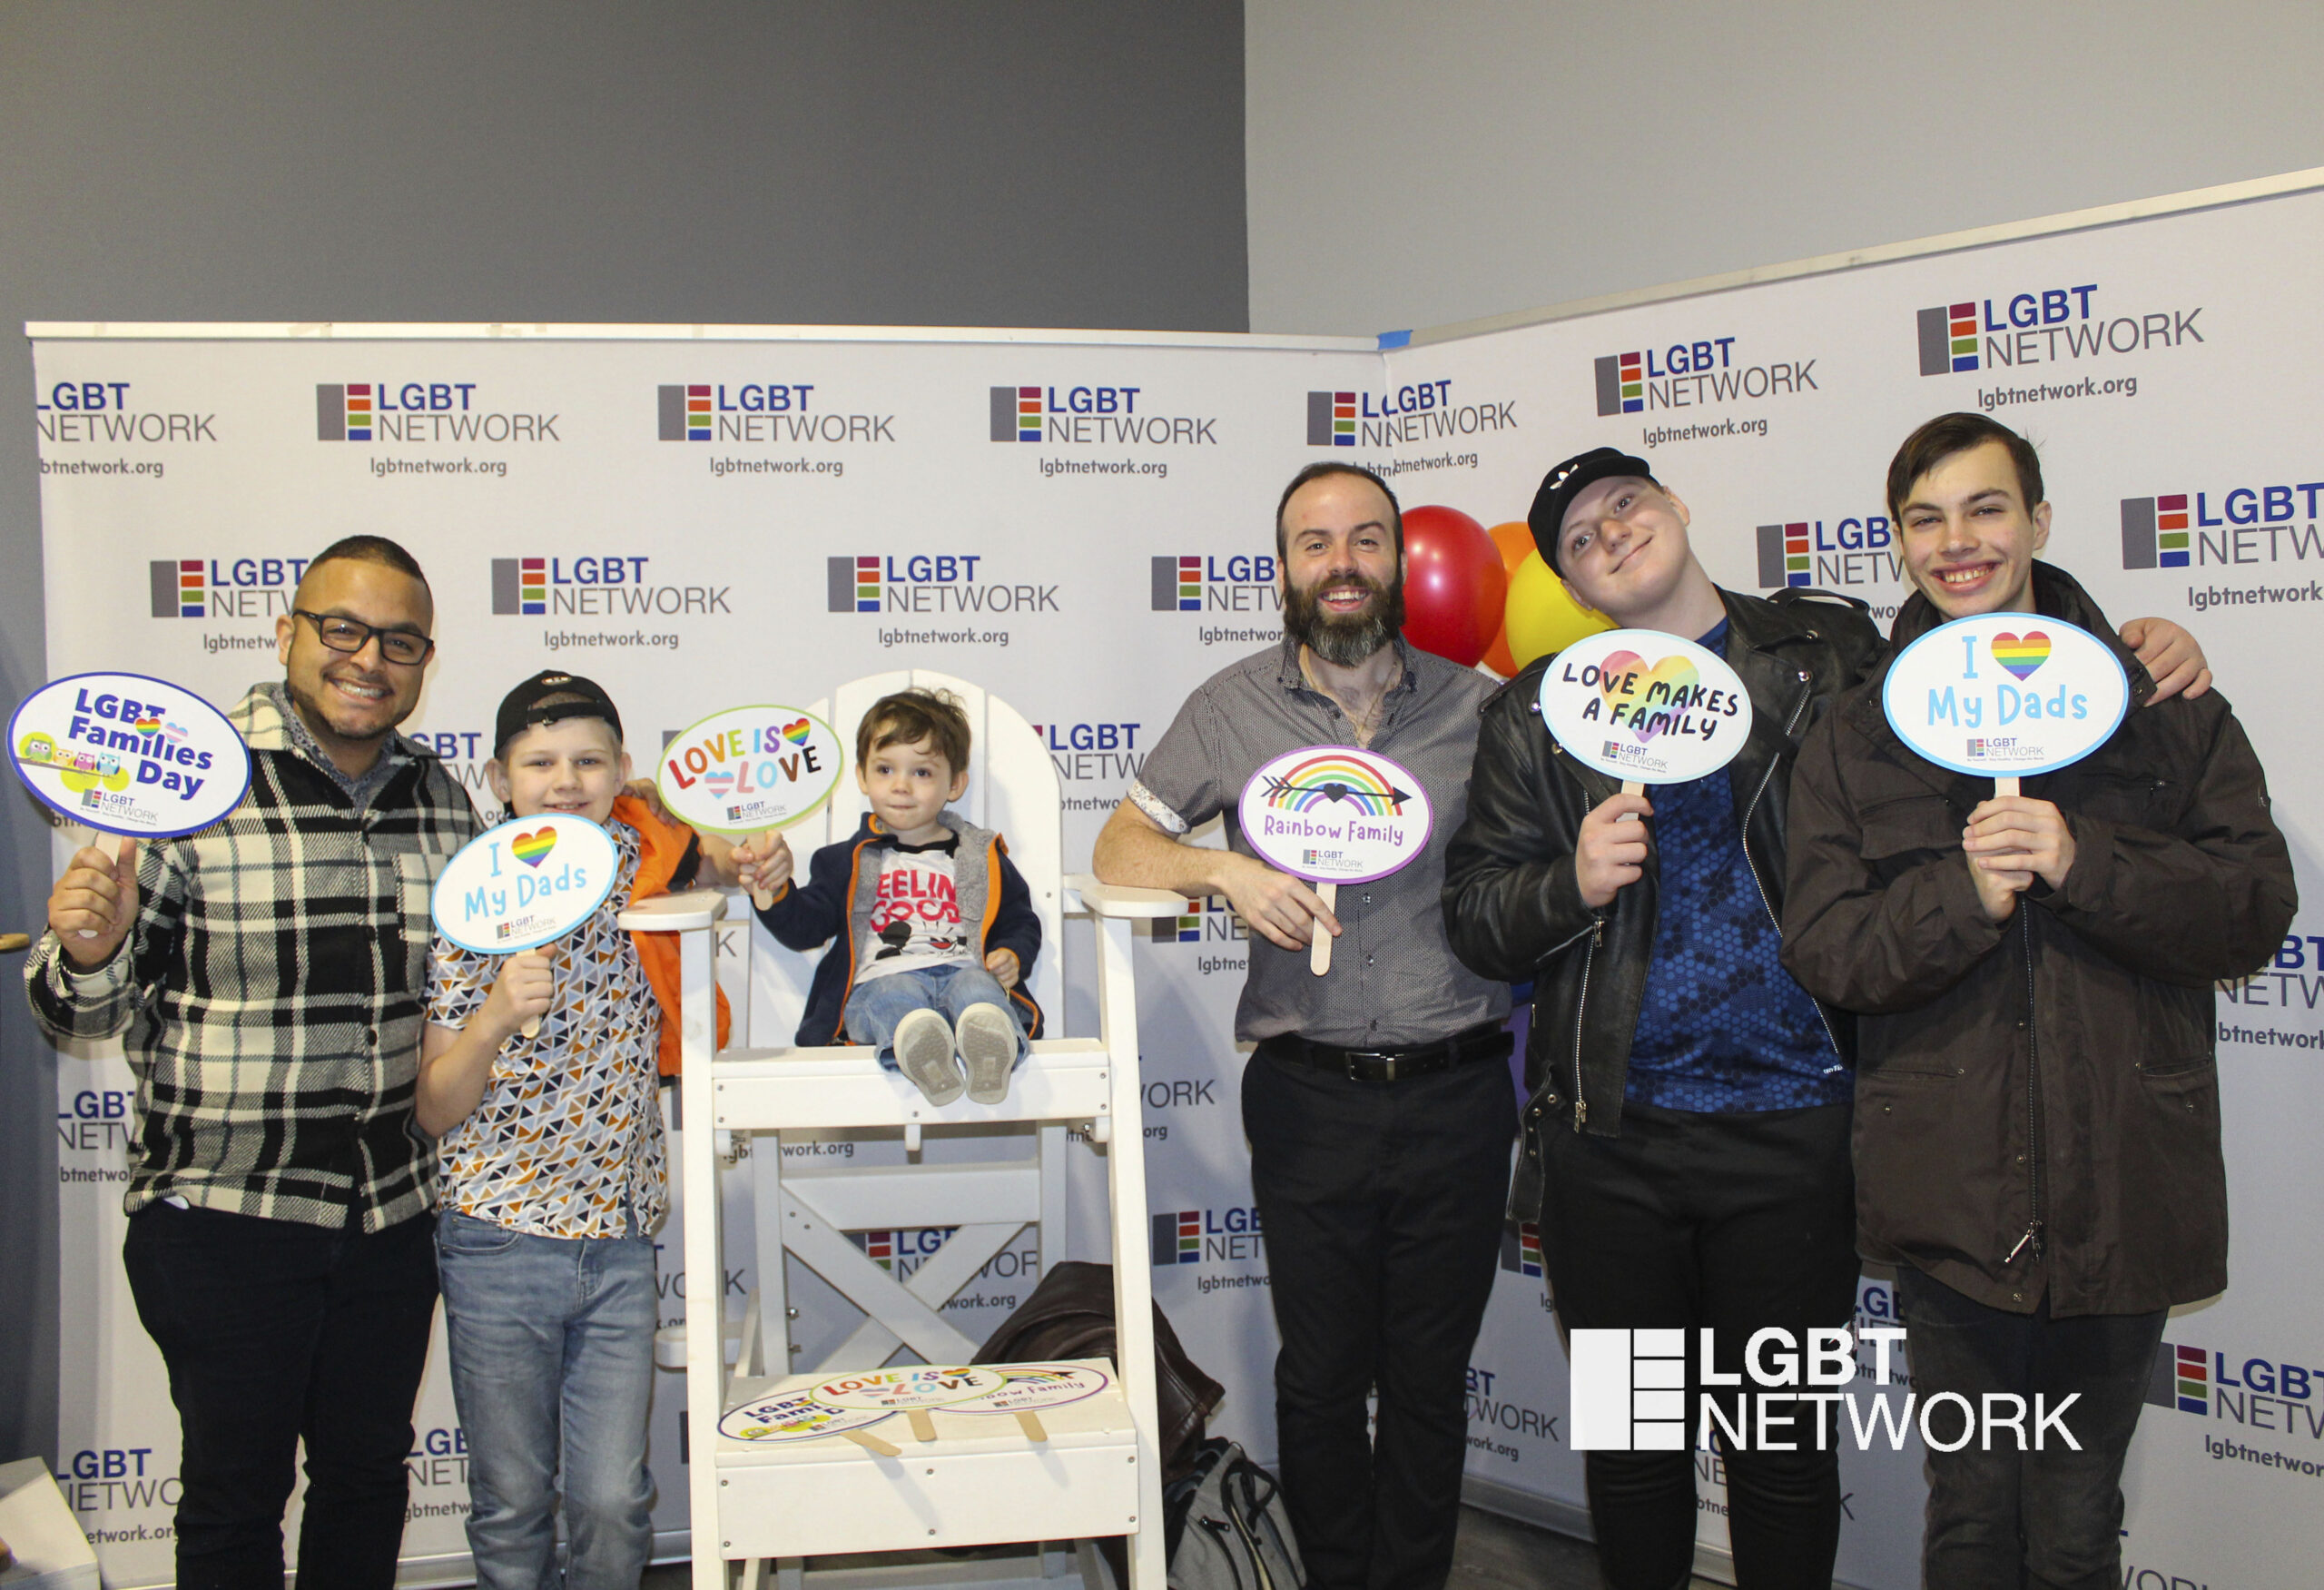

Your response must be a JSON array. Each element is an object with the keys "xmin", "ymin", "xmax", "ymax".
[{"xmin": 428, "ymin": 821, "xmax": 669, "ymax": 1237}]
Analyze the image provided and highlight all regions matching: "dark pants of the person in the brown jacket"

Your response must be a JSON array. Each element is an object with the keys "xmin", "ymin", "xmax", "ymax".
[{"xmin": 1896, "ymin": 1265, "xmax": 2168, "ymax": 1590}]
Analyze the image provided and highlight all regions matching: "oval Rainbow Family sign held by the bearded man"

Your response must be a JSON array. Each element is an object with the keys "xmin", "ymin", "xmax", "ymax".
[{"xmin": 1236, "ymin": 746, "xmax": 1436, "ymax": 976}]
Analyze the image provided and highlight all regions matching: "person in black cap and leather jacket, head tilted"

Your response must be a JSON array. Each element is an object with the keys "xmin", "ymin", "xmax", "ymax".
[{"xmin": 1445, "ymin": 447, "xmax": 2208, "ymax": 1590}]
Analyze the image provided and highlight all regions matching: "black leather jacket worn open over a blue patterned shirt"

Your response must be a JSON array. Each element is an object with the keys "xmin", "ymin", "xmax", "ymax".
[{"xmin": 1445, "ymin": 590, "xmax": 1887, "ymax": 1220}]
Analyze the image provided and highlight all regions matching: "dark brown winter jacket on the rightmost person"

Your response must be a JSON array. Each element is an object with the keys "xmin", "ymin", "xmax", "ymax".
[{"xmin": 1783, "ymin": 563, "xmax": 2296, "ymax": 1316}]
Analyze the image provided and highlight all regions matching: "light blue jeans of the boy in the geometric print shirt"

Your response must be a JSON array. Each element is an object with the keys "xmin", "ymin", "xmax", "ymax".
[{"xmin": 437, "ymin": 1209, "xmax": 657, "ymax": 1590}]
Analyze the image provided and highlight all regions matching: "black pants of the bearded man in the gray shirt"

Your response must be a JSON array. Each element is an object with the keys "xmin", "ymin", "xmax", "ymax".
[{"xmin": 1244, "ymin": 1055, "xmax": 1518, "ymax": 1590}]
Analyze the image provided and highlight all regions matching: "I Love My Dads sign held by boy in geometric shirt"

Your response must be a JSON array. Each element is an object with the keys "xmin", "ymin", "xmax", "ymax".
[{"xmin": 430, "ymin": 811, "xmax": 621, "ymax": 955}]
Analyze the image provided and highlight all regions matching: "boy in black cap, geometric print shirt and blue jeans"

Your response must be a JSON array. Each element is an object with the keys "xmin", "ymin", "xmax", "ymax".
[{"xmin": 416, "ymin": 669, "xmax": 758, "ymax": 1590}]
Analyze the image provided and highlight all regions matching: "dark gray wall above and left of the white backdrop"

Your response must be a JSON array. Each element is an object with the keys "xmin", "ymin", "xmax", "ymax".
[{"xmin": 0, "ymin": 0, "xmax": 1246, "ymax": 1460}]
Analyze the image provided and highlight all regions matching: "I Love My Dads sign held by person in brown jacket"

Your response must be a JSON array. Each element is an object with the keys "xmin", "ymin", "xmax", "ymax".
[{"xmin": 1880, "ymin": 614, "xmax": 2132, "ymax": 793}]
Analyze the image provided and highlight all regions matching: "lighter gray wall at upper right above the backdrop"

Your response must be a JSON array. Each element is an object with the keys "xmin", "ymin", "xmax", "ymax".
[{"xmin": 1244, "ymin": 0, "xmax": 2324, "ymax": 332}]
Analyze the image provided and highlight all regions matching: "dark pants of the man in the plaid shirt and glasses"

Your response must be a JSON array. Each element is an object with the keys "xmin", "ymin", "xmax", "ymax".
[{"xmin": 121, "ymin": 1204, "xmax": 437, "ymax": 1590}]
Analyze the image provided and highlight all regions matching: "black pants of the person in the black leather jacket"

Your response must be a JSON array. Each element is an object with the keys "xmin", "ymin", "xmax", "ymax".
[{"xmin": 1541, "ymin": 1104, "xmax": 1856, "ymax": 1590}]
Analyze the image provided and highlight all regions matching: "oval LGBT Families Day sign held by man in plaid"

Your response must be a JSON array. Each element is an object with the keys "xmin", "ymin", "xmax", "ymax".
[{"xmin": 7, "ymin": 674, "xmax": 251, "ymax": 839}]
